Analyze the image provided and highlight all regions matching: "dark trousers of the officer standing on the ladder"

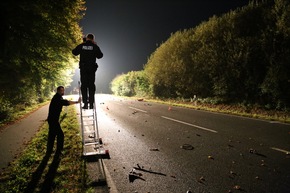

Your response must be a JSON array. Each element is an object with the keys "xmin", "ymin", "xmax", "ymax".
[{"xmin": 80, "ymin": 66, "xmax": 96, "ymax": 104}]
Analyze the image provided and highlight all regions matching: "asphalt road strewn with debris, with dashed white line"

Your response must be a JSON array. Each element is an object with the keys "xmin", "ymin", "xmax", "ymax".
[{"xmin": 96, "ymin": 95, "xmax": 290, "ymax": 193}]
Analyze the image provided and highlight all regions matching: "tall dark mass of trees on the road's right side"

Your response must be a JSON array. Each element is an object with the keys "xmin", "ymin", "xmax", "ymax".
[{"xmin": 112, "ymin": 0, "xmax": 290, "ymax": 109}]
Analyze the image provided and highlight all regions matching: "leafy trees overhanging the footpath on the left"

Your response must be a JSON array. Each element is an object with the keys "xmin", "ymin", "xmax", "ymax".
[{"xmin": 0, "ymin": 0, "xmax": 85, "ymax": 120}]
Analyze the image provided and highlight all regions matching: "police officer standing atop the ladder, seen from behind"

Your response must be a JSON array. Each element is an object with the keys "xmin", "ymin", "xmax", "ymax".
[{"xmin": 72, "ymin": 34, "xmax": 103, "ymax": 109}]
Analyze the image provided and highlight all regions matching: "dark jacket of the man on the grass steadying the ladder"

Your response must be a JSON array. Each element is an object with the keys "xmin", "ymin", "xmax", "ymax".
[{"xmin": 47, "ymin": 93, "xmax": 69, "ymax": 122}]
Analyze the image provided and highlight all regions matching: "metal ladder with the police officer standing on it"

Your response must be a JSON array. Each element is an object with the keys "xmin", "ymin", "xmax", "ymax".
[{"xmin": 79, "ymin": 82, "xmax": 109, "ymax": 158}]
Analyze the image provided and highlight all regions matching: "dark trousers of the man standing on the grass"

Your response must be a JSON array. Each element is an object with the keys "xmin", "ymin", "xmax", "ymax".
[{"xmin": 46, "ymin": 121, "xmax": 64, "ymax": 154}]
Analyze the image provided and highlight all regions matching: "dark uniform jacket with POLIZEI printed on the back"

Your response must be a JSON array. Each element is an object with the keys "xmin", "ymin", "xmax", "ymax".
[{"xmin": 72, "ymin": 40, "xmax": 103, "ymax": 68}]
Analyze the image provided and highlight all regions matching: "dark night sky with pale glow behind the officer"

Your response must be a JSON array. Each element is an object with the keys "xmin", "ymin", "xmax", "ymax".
[{"xmin": 74, "ymin": 0, "xmax": 249, "ymax": 93}]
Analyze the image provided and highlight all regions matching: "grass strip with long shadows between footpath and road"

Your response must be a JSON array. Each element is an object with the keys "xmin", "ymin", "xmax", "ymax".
[{"xmin": 0, "ymin": 106, "xmax": 86, "ymax": 193}]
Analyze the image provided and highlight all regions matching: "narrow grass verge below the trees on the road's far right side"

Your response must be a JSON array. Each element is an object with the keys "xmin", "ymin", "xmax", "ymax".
[{"xmin": 130, "ymin": 96, "xmax": 290, "ymax": 123}]
